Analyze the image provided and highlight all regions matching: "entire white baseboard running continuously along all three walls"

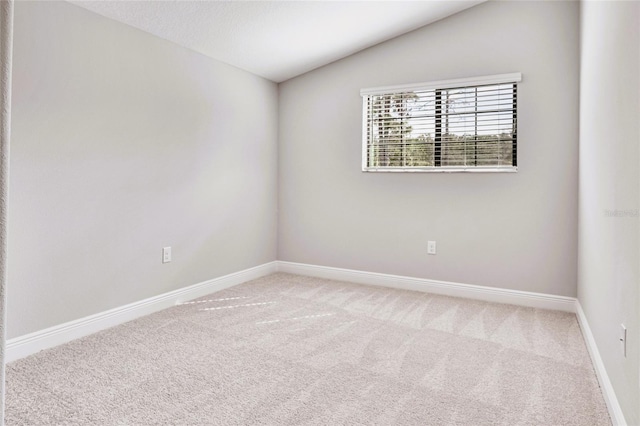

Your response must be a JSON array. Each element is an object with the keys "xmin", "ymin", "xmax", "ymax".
[{"xmin": 5, "ymin": 261, "xmax": 626, "ymax": 426}]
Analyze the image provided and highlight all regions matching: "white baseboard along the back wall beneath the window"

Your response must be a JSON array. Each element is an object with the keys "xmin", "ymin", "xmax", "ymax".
[{"xmin": 278, "ymin": 261, "xmax": 576, "ymax": 313}]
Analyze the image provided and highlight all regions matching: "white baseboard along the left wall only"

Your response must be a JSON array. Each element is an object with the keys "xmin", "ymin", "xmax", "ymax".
[{"xmin": 5, "ymin": 262, "xmax": 278, "ymax": 362}]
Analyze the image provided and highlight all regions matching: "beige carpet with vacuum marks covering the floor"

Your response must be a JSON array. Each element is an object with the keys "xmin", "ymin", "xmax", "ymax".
[{"xmin": 6, "ymin": 273, "xmax": 610, "ymax": 425}]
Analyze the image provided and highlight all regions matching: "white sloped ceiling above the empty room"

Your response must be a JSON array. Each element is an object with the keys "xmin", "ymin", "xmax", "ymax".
[{"xmin": 69, "ymin": 0, "xmax": 485, "ymax": 82}]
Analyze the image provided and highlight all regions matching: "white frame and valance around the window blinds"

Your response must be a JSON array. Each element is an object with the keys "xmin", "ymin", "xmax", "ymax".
[{"xmin": 360, "ymin": 73, "xmax": 522, "ymax": 173}]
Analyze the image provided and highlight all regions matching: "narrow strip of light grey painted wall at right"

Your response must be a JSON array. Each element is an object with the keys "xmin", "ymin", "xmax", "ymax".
[{"xmin": 578, "ymin": 1, "xmax": 640, "ymax": 425}]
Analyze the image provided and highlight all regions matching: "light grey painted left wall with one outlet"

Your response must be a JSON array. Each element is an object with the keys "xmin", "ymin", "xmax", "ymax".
[{"xmin": 7, "ymin": 1, "xmax": 278, "ymax": 338}]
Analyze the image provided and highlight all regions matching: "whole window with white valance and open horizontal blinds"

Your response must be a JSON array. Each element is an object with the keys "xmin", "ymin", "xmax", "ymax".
[{"xmin": 360, "ymin": 73, "xmax": 521, "ymax": 172}]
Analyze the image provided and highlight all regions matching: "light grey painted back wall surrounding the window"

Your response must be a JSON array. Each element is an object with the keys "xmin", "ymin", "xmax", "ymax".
[{"xmin": 278, "ymin": 2, "xmax": 579, "ymax": 296}]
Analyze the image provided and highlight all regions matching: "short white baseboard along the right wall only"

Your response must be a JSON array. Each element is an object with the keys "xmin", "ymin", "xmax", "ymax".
[{"xmin": 576, "ymin": 301, "xmax": 627, "ymax": 426}]
